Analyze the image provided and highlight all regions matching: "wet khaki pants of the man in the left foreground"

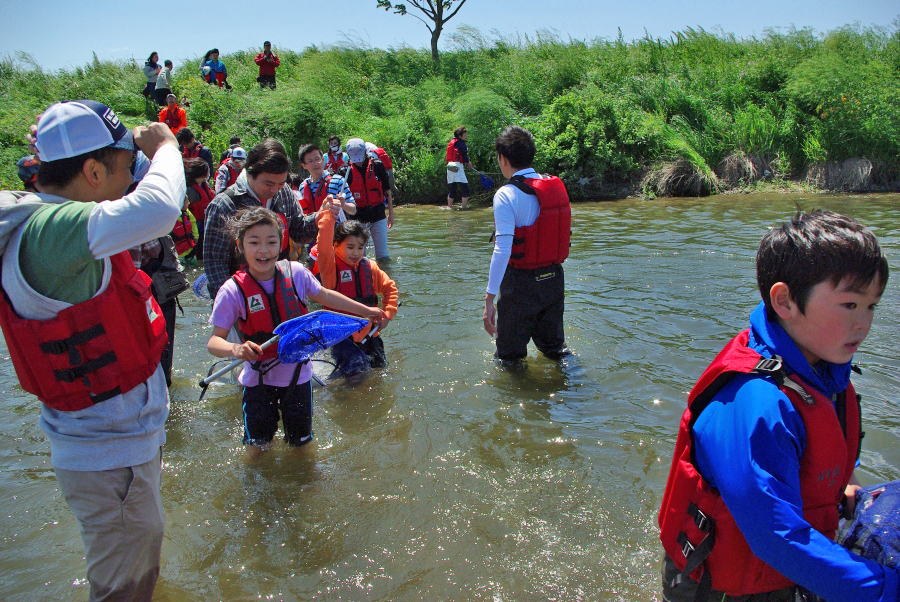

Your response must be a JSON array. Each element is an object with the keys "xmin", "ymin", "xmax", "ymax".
[{"xmin": 56, "ymin": 451, "xmax": 163, "ymax": 602}]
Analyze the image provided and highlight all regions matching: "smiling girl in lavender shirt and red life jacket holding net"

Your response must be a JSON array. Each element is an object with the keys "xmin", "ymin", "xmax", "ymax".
[{"xmin": 206, "ymin": 207, "xmax": 385, "ymax": 461}]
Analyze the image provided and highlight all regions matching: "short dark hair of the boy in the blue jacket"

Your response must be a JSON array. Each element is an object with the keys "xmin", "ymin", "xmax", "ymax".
[{"xmin": 756, "ymin": 209, "xmax": 889, "ymax": 320}]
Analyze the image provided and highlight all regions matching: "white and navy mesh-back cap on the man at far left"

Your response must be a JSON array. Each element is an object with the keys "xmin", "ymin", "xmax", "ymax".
[{"xmin": 35, "ymin": 100, "xmax": 135, "ymax": 161}]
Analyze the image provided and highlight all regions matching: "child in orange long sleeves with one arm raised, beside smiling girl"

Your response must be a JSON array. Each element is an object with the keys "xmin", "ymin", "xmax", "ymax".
[{"xmin": 316, "ymin": 195, "xmax": 398, "ymax": 377}]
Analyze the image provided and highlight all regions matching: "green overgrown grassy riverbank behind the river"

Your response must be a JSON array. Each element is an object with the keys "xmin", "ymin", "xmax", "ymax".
[{"xmin": 0, "ymin": 19, "xmax": 900, "ymax": 201}]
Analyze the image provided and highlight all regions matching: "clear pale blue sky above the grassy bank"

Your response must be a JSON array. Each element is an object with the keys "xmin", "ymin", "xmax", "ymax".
[{"xmin": 0, "ymin": 0, "xmax": 900, "ymax": 70}]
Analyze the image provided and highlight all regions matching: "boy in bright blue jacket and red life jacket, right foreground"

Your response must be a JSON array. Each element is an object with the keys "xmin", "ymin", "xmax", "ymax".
[{"xmin": 659, "ymin": 211, "xmax": 900, "ymax": 602}]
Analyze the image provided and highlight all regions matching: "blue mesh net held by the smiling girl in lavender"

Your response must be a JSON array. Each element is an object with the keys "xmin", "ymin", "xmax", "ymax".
[{"xmin": 275, "ymin": 310, "xmax": 369, "ymax": 364}]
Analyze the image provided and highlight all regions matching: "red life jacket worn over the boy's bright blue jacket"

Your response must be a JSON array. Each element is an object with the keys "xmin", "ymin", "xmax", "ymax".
[{"xmin": 659, "ymin": 330, "xmax": 860, "ymax": 596}]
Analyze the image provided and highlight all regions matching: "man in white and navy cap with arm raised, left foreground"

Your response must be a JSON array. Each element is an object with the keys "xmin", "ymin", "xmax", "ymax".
[{"xmin": 0, "ymin": 100, "xmax": 185, "ymax": 600}]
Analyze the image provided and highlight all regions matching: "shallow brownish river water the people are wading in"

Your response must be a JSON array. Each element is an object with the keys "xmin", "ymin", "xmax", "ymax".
[{"xmin": 0, "ymin": 195, "xmax": 900, "ymax": 602}]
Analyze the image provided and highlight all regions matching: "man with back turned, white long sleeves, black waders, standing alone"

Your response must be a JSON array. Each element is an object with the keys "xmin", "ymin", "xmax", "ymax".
[{"xmin": 484, "ymin": 125, "xmax": 572, "ymax": 361}]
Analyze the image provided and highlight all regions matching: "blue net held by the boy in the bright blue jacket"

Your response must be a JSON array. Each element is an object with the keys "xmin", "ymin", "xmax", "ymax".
[{"xmin": 837, "ymin": 481, "xmax": 900, "ymax": 568}]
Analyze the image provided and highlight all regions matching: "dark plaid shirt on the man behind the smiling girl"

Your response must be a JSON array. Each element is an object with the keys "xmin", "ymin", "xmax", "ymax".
[{"xmin": 203, "ymin": 172, "xmax": 319, "ymax": 299}]
